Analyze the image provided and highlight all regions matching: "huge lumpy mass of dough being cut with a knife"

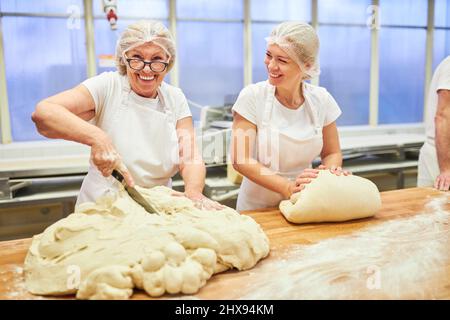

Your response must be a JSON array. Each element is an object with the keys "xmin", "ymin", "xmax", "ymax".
[{"xmin": 25, "ymin": 187, "xmax": 269, "ymax": 299}]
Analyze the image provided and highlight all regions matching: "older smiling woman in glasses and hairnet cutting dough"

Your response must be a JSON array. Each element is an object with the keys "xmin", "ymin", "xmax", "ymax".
[{"xmin": 32, "ymin": 21, "xmax": 220, "ymax": 208}]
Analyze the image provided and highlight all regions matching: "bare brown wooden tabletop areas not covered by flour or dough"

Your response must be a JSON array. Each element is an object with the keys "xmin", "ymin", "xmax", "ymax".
[{"xmin": 0, "ymin": 188, "xmax": 450, "ymax": 299}]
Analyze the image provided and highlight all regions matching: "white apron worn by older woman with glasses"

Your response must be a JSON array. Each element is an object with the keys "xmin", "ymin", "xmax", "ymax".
[{"xmin": 76, "ymin": 78, "xmax": 179, "ymax": 205}]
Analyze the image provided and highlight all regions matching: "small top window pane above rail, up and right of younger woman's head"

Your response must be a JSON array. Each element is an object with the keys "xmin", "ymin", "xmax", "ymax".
[{"xmin": 318, "ymin": 0, "xmax": 371, "ymax": 24}]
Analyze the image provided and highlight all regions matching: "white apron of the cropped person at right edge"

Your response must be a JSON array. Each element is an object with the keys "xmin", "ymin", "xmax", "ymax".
[{"xmin": 417, "ymin": 138, "xmax": 440, "ymax": 187}]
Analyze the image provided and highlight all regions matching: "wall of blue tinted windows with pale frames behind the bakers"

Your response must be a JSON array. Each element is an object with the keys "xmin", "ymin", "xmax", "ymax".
[{"xmin": 0, "ymin": 0, "xmax": 450, "ymax": 142}]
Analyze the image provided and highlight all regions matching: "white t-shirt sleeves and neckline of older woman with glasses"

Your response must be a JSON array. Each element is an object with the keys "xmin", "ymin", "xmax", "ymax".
[{"xmin": 82, "ymin": 71, "xmax": 191, "ymax": 127}]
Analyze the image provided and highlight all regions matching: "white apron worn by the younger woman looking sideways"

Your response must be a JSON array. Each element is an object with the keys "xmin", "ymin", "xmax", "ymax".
[{"xmin": 236, "ymin": 85, "xmax": 323, "ymax": 211}]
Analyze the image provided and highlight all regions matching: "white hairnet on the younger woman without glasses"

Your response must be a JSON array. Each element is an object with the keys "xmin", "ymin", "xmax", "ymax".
[{"xmin": 266, "ymin": 21, "xmax": 320, "ymax": 79}]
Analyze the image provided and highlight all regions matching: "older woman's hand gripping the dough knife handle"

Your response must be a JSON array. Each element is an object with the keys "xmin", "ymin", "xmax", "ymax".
[{"xmin": 91, "ymin": 136, "xmax": 134, "ymax": 187}]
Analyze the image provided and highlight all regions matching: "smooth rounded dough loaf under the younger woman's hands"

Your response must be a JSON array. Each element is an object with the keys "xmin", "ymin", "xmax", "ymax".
[{"xmin": 280, "ymin": 170, "xmax": 381, "ymax": 223}]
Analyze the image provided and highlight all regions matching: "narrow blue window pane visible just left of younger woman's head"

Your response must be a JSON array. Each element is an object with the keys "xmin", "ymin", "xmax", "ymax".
[{"xmin": 252, "ymin": 23, "xmax": 277, "ymax": 83}]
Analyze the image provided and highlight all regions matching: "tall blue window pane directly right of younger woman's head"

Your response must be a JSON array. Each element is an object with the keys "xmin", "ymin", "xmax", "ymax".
[{"xmin": 319, "ymin": 26, "xmax": 370, "ymax": 125}]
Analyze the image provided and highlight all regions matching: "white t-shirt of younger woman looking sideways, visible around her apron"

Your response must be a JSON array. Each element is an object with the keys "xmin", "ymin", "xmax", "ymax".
[{"xmin": 232, "ymin": 81, "xmax": 342, "ymax": 139}]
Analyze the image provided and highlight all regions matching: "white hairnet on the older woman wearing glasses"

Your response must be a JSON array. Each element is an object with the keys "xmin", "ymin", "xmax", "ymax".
[{"xmin": 116, "ymin": 20, "xmax": 176, "ymax": 75}]
